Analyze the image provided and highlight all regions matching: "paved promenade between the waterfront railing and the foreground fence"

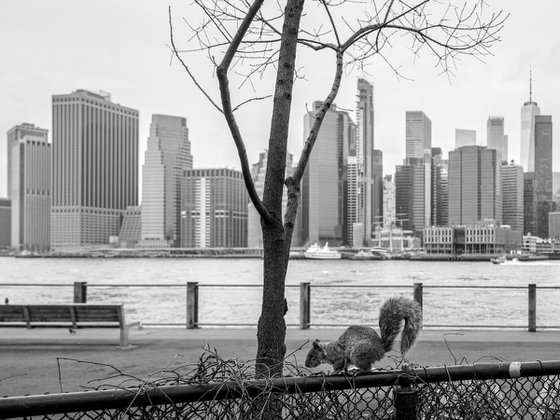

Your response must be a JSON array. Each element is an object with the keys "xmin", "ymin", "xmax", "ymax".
[{"xmin": 0, "ymin": 328, "xmax": 560, "ymax": 396}]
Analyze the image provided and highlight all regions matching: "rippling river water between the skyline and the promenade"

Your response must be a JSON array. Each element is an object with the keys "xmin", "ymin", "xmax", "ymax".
[{"xmin": 0, "ymin": 258, "xmax": 560, "ymax": 327}]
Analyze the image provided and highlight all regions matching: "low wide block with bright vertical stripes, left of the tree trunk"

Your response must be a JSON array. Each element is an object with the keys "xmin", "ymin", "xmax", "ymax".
[{"xmin": 181, "ymin": 168, "xmax": 249, "ymax": 248}]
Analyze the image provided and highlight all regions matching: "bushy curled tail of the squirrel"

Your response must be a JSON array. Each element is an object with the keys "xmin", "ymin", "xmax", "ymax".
[{"xmin": 379, "ymin": 297, "xmax": 422, "ymax": 355}]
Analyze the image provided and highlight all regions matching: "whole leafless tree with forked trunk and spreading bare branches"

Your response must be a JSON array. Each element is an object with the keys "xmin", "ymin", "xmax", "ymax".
[{"xmin": 169, "ymin": 0, "xmax": 507, "ymax": 376}]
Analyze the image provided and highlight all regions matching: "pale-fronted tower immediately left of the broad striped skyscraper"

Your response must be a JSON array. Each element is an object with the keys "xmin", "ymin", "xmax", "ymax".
[{"xmin": 8, "ymin": 126, "xmax": 51, "ymax": 252}]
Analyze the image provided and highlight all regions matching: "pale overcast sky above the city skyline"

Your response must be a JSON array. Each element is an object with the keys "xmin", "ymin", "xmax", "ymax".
[{"xmin": 0, "ymin": 0, "xmax": 560, "ymax": 196}]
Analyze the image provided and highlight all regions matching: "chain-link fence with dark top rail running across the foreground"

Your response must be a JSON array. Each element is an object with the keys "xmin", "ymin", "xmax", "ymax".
[{"xmin": 0, "ymin": 361, "xmax": 560, "ymax": 420}]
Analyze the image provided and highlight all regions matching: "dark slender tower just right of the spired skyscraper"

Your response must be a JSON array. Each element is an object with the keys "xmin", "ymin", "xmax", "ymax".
[{"xmin": 534, "ymin": 115, "xmax": 554, "ymax": 238}]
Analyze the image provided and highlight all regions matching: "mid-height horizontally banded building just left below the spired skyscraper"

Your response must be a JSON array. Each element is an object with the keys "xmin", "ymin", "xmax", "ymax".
[{"xmin": 502, "ymin": 163, "xmax": 523, "ymax": 231}]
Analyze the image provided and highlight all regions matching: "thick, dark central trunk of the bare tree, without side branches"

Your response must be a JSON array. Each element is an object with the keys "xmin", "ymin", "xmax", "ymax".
[{"xmin": 256, "ymin": 0, "xmax": 304, "ymax": 376}]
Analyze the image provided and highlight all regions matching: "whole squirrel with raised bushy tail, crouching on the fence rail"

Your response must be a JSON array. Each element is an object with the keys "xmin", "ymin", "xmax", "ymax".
[{"xmin": 305, "ymin": 297, "xmax": 422, "ymax": 373}]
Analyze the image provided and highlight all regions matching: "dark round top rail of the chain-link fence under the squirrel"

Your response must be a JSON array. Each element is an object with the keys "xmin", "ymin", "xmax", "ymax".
[{"xmin": 0, "ymin": 360, "xmax": 560, "ymax": 418}]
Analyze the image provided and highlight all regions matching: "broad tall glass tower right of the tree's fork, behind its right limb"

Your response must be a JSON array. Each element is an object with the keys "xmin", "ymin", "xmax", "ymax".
[{"xmin": 301, "ymin": 102, "xmax": 356, "ymax": 246}]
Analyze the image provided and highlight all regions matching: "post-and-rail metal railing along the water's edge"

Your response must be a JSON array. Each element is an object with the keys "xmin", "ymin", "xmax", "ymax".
[{"xmin": 0, "ymin": 282, "xmax": 560, "ymax": 332}]
